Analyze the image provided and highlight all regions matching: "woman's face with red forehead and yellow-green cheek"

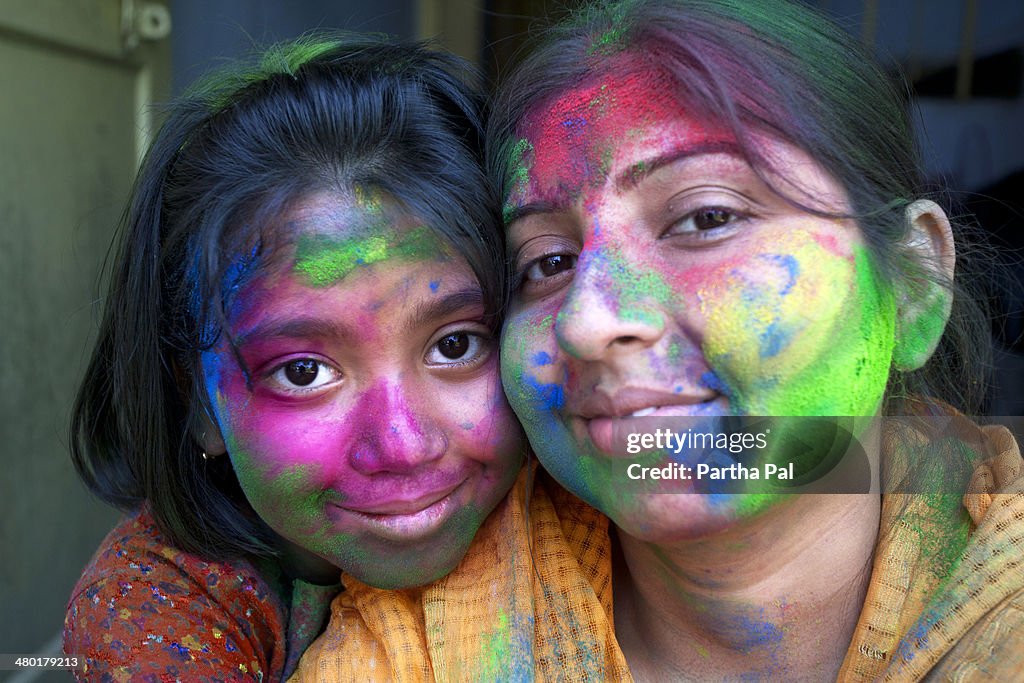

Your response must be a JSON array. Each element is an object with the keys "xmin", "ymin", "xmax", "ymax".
[{"xmin": 502, "ymin": 72, "xmax": 895, "ymax": 541}]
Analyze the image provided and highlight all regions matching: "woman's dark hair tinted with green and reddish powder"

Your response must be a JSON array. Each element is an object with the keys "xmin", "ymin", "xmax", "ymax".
[{"xmin": 487, "ymin": 0, "xmax": 990, "ymax": 414}]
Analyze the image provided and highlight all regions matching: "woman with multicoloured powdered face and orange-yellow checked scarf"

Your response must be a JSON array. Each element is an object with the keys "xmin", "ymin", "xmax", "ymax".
[{"xmin": 490, "ymin": 0, "xmax": 1024, "ymax": 680}]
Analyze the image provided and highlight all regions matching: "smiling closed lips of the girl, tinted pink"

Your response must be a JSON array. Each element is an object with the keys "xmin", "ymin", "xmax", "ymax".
[{"xmin": 336, "ymin": 480, "xmax": 465, "ymax": 542}]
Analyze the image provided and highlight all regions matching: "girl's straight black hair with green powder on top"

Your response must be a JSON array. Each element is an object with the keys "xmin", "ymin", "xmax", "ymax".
[{"xmin": 72, "ymin": 35, "xmax": 505, "ymax": 559}]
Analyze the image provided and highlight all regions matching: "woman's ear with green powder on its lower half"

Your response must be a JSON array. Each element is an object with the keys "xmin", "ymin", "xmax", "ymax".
[{"xmin": 893, "ymin": 200, "xmax": 956, "ymax": 372}]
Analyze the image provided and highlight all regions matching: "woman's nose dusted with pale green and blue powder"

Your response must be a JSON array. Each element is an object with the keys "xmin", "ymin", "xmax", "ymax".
[{"xmin": 555, "ymin": 248, "xmax": 665, "ymax": 360}]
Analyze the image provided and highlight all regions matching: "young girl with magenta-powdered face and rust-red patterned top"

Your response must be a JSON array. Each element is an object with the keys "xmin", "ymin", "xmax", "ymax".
[{"xmin": 65, "ymin": 37, "xmax": 522, "ymax": 681}]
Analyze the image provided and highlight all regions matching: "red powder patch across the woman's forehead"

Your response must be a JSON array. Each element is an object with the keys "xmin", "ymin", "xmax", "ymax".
[{"xmin": 521, "ymin": 59, "xmax": 732, "ymax": 201}]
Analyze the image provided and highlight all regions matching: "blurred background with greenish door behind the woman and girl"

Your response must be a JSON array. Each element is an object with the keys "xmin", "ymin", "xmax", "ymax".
[{"xmin": 0, "ymin": 0, "xmax": 1024, "ymax": 683}]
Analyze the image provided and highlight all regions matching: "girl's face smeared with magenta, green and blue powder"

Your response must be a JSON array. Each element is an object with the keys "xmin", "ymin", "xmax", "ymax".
[{"xmin": 202, "ymin": 193, "xmax": 523, "ymax": 588}]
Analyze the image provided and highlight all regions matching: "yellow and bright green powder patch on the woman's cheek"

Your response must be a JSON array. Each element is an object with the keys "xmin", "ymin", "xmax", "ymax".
[{"xmin": 699, "ymin": 231, "xmax": 895, "ymax": 416}]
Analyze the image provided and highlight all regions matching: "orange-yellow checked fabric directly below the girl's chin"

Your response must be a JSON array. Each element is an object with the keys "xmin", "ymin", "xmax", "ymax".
[{"xmin": 290, "ymin": 470, "xmax": 632, "ymax": 683}]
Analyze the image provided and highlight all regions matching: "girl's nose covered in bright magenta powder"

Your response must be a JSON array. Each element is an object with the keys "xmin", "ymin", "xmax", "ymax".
[{"xmin": 349, "ymin": 384, "xmax": 447, "ymax": 475}]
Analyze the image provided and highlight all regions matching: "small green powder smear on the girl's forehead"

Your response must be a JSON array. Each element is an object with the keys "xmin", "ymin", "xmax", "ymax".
[{"xmin": 293, "ymin": 223, "xmax": 437, "ymax": 287}]
